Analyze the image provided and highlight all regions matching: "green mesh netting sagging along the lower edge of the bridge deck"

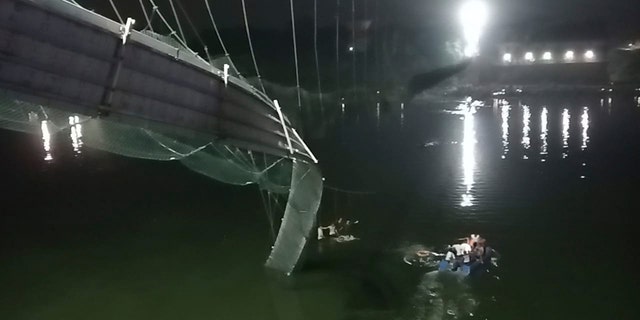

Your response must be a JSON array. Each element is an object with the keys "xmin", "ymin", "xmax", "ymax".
[{"xmin": 0, "ymin": 92, "xmax": 292, "ymax": 194}]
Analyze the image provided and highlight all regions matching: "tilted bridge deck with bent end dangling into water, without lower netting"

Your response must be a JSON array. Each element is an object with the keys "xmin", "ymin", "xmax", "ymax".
[{"xmin": 0, "ymin": 0, "xmax": 322, "ymax": 273}]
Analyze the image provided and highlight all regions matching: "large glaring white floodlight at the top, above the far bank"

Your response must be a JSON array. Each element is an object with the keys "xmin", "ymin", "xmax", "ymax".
[{"xmin": 460, "ymin": 0, "xmax": 487, "ymax": 57}]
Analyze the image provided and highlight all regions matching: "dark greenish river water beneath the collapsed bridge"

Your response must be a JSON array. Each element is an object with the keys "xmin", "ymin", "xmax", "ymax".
[{"xmin": 0, "ymin": 94, "xmax": 640, "ymax": 319}]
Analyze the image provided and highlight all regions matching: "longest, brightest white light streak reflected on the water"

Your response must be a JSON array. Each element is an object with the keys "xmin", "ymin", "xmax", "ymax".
[{"xmin": 460, "ymin": 105, "xmax": 476, "ymax": 207}]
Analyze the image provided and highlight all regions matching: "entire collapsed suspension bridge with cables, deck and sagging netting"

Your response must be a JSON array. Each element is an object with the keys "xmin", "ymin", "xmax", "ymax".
[{"xmin": 0, "ymin": 0, "xmax": 323, "ymax": 274}]
